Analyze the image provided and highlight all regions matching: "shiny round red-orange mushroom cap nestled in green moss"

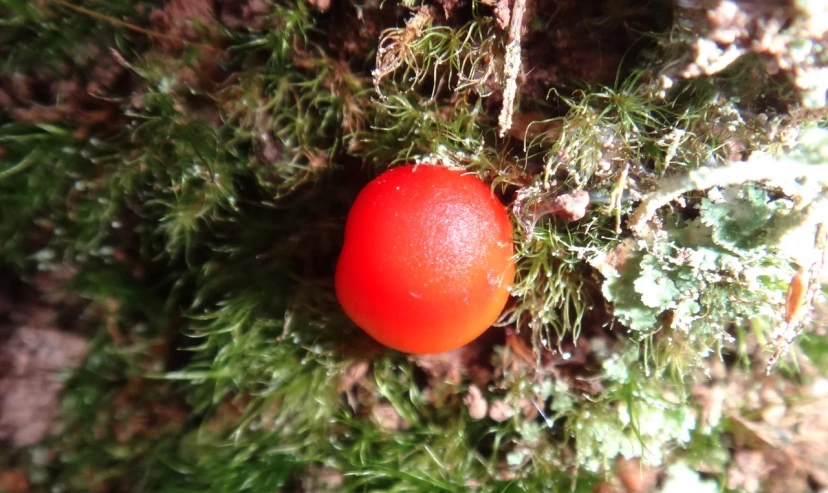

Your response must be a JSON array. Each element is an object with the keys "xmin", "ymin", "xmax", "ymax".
[{"xmin": 336, "ymin": 165, "xmax": 515, "ymax": 354}]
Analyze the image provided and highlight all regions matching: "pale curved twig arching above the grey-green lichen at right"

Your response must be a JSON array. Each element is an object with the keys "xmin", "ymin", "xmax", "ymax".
[{"xmin": 627, "ymin": 156, "xmax": 828, "ymax": 236}]
